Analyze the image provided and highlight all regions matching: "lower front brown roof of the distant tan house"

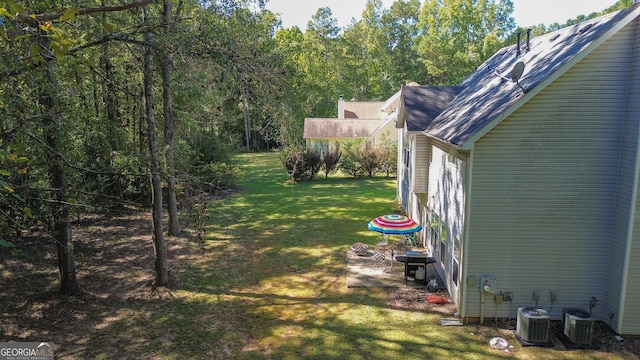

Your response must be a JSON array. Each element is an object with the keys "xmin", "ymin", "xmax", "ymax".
[{"xmin": 303, "ymin": 118, "xmax": 385, "ymax": 139}]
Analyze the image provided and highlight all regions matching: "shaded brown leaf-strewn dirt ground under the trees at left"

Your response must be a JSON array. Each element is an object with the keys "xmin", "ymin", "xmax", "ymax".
[{"xmin": 0, "ymin": 211, "xmax": 198, "ymax": 358}]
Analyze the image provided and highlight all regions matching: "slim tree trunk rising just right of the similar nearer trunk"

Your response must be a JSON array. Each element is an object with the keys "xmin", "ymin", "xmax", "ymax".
[{"xmin": 160, "ymin": 0, "xmax": 181, "ymax": 235}]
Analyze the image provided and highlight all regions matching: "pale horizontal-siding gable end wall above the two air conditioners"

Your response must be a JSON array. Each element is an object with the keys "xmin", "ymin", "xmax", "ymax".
[{"xmin": 463, "ymin": 24, "xmax": 631, "ymax": 319}]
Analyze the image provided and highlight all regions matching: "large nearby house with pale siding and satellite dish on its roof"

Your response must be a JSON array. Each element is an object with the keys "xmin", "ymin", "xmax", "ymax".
[{"xmin": 397, "ymin": 4, "xmax": 640, "ymax": 335}]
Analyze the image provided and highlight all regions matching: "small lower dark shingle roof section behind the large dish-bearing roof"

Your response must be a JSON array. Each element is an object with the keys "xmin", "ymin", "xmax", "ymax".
[{"xmin": 396, "ymin": 86, "xmax": 463, "ymax": 131}]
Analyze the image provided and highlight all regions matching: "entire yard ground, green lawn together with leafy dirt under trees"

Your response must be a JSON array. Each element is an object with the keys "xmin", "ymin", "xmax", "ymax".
[{"xmin": 0, "ymin": 153, "xmax": 637, "ymax": 360}]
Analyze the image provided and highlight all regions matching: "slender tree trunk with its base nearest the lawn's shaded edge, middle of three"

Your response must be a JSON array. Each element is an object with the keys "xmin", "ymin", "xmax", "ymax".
[{"xmin": 143, "ymin": 6, "xmax": 169, "ymax": 286}]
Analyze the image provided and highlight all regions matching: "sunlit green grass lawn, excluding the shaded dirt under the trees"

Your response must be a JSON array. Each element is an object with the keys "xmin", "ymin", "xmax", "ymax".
[{"xmin": 98, "ymin": 153, "xmax": 622, "ymax": 359}]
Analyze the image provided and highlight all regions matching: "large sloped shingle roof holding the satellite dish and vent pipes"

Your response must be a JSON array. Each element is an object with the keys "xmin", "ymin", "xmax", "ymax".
[{"xmin": 422, "ymin": 4, "xmax": 640, "ymax": 149}]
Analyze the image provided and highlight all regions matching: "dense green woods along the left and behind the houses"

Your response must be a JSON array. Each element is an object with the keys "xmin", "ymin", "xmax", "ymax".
[{"xmin": 0, "ymin": 0, "xmax": 632, "ymax": 294}]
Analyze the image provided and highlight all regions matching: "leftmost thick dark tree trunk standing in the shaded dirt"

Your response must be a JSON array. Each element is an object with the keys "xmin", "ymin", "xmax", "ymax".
[{"xmin": 40, "ymin": 44, "xmax": 81, "ymax": 295}]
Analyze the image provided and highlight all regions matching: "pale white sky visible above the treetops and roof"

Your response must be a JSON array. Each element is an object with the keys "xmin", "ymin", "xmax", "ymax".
[{"xmin": 267, "ymin": 0, "xmax": 616, "ymax": 31}]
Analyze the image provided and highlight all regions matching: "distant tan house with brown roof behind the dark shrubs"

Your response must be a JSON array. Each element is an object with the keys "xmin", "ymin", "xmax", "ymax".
[{"xmin": 303, "ymin": 93, "xmax": 399, "ymax": 153}]
